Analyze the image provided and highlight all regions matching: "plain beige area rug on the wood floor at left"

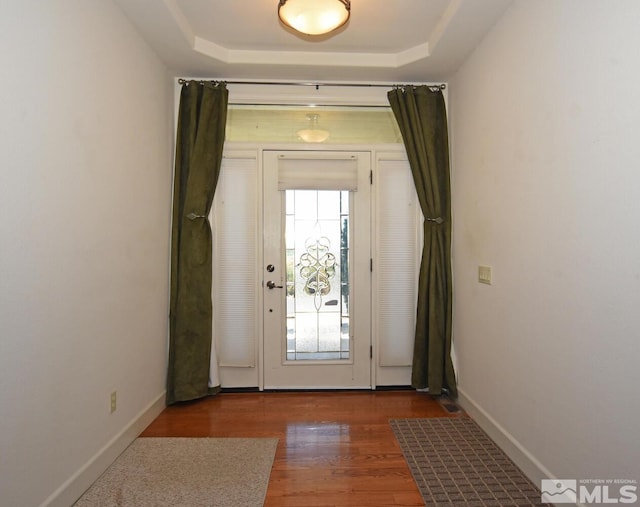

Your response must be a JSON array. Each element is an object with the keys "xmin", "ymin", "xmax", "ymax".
[{"xmin": 74, "ymin": 438, "xmax": 278, "ymax": 507}]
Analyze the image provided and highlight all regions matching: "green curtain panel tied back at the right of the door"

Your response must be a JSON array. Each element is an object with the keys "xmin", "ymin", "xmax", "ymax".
[{"xmin": 388, "ymin": 86, "xmax": 458, "ymax": 398}]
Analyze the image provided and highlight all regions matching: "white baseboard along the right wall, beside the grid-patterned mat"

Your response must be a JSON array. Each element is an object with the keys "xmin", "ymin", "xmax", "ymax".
[{"xmin": 457, "ymin": 389, "xmax": 554, "ymax": 487}]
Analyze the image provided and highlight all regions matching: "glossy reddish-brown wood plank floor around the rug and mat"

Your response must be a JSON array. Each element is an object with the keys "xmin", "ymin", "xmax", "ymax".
[{"xmin": 141, "ymin": 391, "xmax": 455, "ymax": 507}]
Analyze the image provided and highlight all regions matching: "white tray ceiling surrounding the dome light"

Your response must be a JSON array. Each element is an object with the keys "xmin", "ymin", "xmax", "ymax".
[{"xmin": 116, "ymin": 0, "xmax": 512, "ymax": 83}]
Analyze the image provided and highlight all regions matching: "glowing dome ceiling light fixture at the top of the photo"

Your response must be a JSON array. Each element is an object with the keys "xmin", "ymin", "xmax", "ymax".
[{"xmin": 278, "ymin": 0, "xmax": 351, "ymax": 35}]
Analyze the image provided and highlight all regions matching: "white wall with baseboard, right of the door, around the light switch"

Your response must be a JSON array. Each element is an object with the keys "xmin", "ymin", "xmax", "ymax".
[{"xmin": 450, "ymin": 0, "xmax": 640, "ymax": 488}]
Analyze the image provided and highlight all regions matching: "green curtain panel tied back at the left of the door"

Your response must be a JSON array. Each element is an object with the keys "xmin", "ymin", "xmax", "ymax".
[{"xmin": 167, "ymin": 81, "xmax": 228, "ymax": 404}]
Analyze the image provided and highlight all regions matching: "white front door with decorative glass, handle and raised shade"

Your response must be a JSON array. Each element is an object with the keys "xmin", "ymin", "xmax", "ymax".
[{"xmin": 262, "ymin": 151, "xmax": 371, "ymax": 389}]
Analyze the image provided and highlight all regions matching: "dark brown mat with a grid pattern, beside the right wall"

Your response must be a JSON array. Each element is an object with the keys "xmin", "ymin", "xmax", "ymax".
[{"xmin": 389, "ymin": 417, "xmax": 548, "ymax": 507}]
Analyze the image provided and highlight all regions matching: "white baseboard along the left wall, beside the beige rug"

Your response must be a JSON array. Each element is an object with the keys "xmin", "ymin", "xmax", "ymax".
[{"xmin": 40, "ymin": 392, "xmax": 166, "ymax": 507}]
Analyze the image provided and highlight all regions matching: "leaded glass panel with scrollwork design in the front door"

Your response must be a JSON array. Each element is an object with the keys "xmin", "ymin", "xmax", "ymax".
[{"xmin": 285, "ymin": 190, "xmax": 350, "ymax": 361}]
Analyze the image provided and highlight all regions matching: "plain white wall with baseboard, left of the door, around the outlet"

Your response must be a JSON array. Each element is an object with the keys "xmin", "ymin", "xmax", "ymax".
[{"xmin": 0, "ymin": 0, "xmax": 172, "ymax": 507}]
